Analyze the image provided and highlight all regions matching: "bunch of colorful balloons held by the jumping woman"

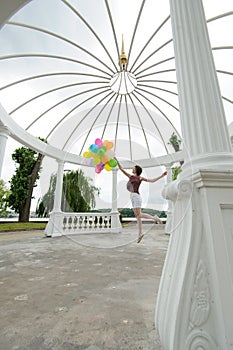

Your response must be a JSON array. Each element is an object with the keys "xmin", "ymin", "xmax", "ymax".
[{"xmin": 83, "ymin": 139, "xmax": 117, "ymax": 174}]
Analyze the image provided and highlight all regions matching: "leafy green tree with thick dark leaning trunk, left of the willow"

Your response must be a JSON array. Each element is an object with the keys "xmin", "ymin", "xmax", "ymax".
[{"xmin": 8, "ymin": 142, "xmax": 44, "ymax": 222}]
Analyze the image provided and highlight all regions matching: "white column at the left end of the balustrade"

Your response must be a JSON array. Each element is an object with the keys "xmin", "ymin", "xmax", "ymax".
[{"xmin": 45, "ymin": 160, "xmax": 64, "ymax": 237}]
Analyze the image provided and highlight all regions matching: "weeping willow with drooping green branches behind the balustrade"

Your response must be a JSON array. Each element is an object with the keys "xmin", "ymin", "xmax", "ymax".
[{"xmin": 36, "ymin": 169, "xmax": 100, "ymax": 217}]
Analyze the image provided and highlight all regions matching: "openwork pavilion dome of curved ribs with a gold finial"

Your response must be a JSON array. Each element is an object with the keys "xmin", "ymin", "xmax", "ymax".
[{"xmin": 0, "ymin": 0, "xmax": 233, "ymax": 160}]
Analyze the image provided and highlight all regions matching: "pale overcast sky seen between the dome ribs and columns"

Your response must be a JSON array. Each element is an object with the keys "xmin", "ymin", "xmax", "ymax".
[{"xmin": 0, "ymin": 0, "xmax": 233, "ymax": 210}]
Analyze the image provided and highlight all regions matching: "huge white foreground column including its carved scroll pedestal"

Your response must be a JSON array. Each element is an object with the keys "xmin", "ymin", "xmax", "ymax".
[{"xmin": 156, "ymin": 0, "xmax": 233, "ymax": 350}]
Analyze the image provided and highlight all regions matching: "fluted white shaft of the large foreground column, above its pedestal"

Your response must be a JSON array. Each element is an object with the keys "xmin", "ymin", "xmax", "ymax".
[{"xmin": 170, "ymin": 0, "xmax": 232, "ymax": 175}]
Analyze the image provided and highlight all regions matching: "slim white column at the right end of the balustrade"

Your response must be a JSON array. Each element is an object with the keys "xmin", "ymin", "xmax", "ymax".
[{"xmin": 111, "ymin": 168, "xmax": 122, "ymax": 233}]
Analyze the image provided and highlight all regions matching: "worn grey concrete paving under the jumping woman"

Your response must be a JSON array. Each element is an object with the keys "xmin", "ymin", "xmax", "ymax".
[{"xmin": 0, "ymin": 223, "xmax": 169, "ymax": 350}]
